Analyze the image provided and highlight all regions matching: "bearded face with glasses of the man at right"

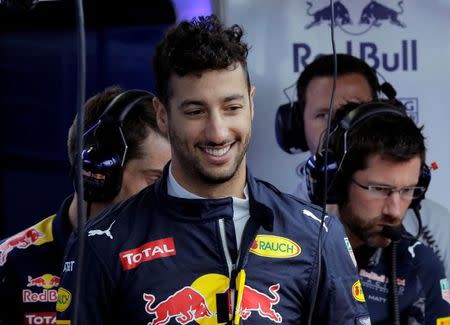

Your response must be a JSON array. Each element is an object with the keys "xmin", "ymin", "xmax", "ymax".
[{"xmin": 339, "ymin": 155, "xmax": 421, "ymax": 248}]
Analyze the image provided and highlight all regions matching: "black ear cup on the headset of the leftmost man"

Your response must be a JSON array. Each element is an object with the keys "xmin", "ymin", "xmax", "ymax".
[{"xmin": 82, "ymin": 147, "xmax": 123, "ymax": 202}]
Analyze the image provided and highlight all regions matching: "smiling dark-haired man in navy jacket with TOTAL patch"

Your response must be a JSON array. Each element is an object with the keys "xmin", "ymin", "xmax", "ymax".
[{"xmin": 57, "ymin": 16, "xmax": 368, "ymax": 324}]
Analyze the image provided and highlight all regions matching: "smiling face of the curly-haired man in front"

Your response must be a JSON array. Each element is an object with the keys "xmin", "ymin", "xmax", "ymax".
[{"xmin": 155, "ymin": 65, "xmax": 255, "ymax": 197}]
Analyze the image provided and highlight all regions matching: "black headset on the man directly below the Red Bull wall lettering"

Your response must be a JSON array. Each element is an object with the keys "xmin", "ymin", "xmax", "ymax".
[{"xmin": 275, "ymin": 57, "xmax": 397, "ymax": 154}]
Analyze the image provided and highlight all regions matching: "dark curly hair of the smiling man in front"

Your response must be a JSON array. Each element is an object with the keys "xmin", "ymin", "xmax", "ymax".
[{"xmin": 153, "ymin": 15, "xmax": 250, "ymax": 106}]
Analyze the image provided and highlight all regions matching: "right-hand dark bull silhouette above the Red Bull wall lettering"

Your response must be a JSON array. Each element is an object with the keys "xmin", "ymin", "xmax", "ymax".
[{"xmin": 359, "ymin": 0, "xmax": 406, "ymax": 28}]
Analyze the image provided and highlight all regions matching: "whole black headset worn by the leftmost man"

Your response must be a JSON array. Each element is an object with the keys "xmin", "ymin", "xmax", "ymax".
[{"xmin": 81, "ymin": 89, "xmax": 154, "ymax": 202}]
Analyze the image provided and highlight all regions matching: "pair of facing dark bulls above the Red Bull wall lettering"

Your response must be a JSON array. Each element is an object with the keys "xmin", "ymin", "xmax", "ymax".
[{"xmin": 305, "ymin": 0, "xmax": 406, "ymax": 35}]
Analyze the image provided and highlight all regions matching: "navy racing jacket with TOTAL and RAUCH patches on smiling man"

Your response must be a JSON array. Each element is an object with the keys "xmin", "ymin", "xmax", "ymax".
[{"xmin": 57, "ymin": 167, "xmax": 370, "ymax": 325}]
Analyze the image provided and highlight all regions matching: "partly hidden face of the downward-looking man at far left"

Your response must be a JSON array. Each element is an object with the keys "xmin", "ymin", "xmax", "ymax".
[{"xmin": 114, "ymin": 131, "xmax": 171, "ymax": 202}]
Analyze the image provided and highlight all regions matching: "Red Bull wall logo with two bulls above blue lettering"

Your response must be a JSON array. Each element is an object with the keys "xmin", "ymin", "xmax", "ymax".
[{"xmin": 293, "ymin": 0, "xmax": 420, "ymax": 73}]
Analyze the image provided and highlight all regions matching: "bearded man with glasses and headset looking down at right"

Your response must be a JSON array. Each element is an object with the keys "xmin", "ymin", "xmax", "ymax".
[{"xmin": 307, "ymin": 102, "xmax": 450, "ymax": 324}]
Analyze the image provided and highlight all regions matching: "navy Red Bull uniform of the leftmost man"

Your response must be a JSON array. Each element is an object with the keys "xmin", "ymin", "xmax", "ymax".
[{"xmin": 0, "ymin": 197, "xmax": 72, "ymax": 325}]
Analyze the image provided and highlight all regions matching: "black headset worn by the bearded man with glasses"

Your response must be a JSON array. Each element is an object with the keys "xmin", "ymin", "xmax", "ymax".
[{"xmin": 305, "ymin": 101, "xmax": 431, "ymax": 208}]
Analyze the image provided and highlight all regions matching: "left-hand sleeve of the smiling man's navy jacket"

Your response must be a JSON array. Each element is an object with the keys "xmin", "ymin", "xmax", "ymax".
[{"xmin": 56, "ymin": 229, "xmax": 114, "ymax": 325}]
